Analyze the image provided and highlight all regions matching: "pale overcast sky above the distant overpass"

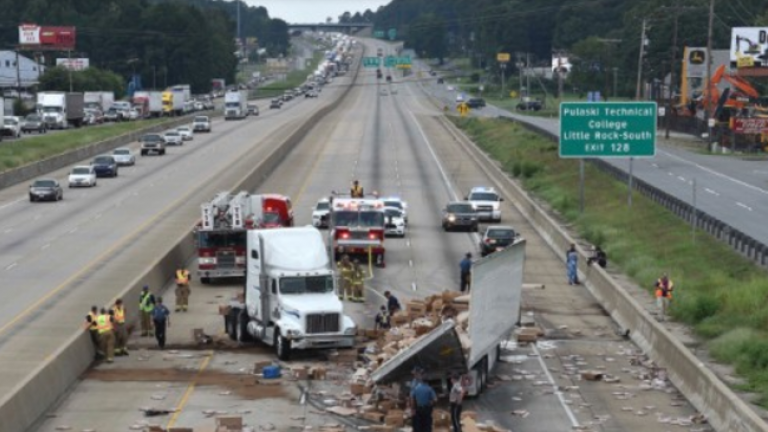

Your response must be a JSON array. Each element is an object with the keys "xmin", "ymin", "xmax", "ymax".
[{"xmin": 245, "ymin": 0, "xmax": 390, "ymax": 24}]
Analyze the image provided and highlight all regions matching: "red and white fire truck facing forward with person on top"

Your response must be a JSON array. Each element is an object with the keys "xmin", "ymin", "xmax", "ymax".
[{"xmin": 330, "ymin": 194, "xmax": 386, "ymax": 267}]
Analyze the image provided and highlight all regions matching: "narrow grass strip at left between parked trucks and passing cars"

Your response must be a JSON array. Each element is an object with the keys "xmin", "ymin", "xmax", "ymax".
[{"xmin": 0, "ymin": 119, "xmax": 169, "ymax": 172}]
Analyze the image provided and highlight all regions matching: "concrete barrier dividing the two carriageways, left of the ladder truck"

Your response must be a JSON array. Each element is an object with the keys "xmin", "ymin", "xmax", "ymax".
[{"xmin": 0, "ymin": 47, "xmax": 361, "ymax": 431}]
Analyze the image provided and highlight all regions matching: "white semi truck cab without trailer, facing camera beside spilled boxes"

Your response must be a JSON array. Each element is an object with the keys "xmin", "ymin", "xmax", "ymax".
[{"xmin": 224, "ymin": 227, "xmax": 357, "ymax": 360}]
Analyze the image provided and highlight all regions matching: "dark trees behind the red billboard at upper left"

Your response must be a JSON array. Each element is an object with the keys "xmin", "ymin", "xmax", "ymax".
[{"xmin": 0, "ymin": 0, "xmax": 289, "ymax": 93}]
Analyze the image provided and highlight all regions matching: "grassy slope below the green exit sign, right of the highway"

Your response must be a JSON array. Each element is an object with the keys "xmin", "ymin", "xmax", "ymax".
[{"xmin": 453, "ymin": 118, "xmax": 768, "ymax": 407}]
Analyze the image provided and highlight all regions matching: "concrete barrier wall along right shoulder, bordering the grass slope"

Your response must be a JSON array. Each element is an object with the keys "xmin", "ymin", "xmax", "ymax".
[{"xmin": 441, "ymin": 117, "xmax": 768, "ymax": 432}]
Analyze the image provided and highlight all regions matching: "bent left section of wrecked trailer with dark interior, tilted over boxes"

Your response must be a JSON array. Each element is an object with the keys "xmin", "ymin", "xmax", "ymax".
[{"xmin": 371, "ymin": 320, "xmax": 467, "ymax": 384}]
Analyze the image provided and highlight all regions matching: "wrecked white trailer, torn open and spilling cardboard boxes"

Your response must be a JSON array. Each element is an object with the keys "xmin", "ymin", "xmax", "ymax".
[{"xmin": 371, "ymin": 239, "xmax": 525, "ymax": 396}]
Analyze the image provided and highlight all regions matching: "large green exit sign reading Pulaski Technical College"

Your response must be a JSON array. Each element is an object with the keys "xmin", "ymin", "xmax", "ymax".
[{"xmin": 560, "ymin": 102, "xmax": 657, "ymax": 158}]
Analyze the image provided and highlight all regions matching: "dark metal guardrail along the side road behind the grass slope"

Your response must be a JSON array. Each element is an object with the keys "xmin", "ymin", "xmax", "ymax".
[{"xmin": 499, "ymin": 117, "xmax": 768, "ymax": 269}]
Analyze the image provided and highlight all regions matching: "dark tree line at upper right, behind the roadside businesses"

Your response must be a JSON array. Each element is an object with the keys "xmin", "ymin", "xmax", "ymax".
[{"xmin": 364, "ymin": 0, "xmax": 768, "ymax": 95}]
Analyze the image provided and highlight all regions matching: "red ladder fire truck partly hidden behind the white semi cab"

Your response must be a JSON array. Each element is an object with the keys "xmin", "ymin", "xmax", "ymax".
[{"xmin": 194, "ymin": 191, "xmax": 293, "ymax": 284}]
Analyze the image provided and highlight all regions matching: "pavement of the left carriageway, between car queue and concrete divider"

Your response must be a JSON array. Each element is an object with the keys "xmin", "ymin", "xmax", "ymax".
[{"xmin": 0, "ymin": 68, "xmax": 341, "ymax": 408}]
